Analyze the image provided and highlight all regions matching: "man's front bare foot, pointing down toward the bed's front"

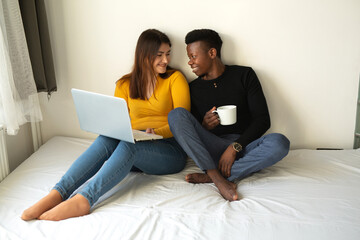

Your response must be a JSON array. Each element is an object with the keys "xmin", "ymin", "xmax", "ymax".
[{"xmin": 207, "ymin": 169, "xmax": 239, "ymax": 201}]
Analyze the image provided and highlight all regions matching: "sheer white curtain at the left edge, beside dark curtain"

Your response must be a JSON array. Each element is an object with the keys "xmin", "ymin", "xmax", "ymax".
[{"xmin": 0, "ymin": 0, "xmax": 42, "ymax": 135}]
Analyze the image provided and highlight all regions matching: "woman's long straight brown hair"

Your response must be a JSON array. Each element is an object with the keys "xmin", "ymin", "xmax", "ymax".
[{"xmin": 120, "ymin": 29, "xmax": 175, "ymax": 100}]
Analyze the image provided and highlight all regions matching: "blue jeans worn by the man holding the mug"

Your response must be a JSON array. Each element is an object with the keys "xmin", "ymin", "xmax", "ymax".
[{"xmin": 168, "ymin": 108, "xmax": 290, "ymax": 181}]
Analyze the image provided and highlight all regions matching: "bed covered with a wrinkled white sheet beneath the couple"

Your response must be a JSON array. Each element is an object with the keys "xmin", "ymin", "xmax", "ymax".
[{"xmin": 0, "ymin": 137, "xmax": 360, "ymax": 240}]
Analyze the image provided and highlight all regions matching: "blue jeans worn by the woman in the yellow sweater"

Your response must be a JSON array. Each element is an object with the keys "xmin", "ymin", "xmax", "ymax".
[{"xmin": 54, "ymin": 136, "xmax": 187, "ymax": 206}]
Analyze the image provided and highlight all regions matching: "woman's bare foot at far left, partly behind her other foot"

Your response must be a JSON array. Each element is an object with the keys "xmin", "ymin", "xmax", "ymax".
[{"xmin": 21, "ymin": 189, "xmax": 62, "ymax": 221}]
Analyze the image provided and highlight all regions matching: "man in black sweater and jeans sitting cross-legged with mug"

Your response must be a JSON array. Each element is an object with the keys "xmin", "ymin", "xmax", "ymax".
[{"xmin": 168, "ymin": 29, "xmax": 290, "ymax": 201}]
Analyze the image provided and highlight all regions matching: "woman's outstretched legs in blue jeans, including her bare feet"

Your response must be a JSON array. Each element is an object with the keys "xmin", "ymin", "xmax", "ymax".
[{"xmin": 21, "ymin": 136, "xmax": 186, "ymax": 221}]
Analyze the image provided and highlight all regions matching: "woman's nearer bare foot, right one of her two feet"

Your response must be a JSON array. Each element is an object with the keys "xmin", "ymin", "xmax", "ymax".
[{"xmin": 39, "ymin": 194, "xmax": 90, "ymax": 221}]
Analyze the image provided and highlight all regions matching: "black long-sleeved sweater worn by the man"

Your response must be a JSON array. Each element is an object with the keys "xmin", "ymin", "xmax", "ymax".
[{"xmin": 190, "ymin": 66, "xmax": 270, "ymax": 147}]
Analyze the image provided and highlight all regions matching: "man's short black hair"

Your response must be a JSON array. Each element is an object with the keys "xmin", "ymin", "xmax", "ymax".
[{"xmin": 185, "ymin": 29, "xmax": 222, "ymax": 59}]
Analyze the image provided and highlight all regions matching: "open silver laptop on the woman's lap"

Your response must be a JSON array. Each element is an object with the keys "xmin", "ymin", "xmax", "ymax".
[{"xmin": 71, "ymin": 88, "xmax": 163, "ymax": 143}]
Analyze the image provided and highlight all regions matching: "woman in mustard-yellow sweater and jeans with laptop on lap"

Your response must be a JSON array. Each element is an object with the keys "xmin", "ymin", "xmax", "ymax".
[{"xmin": 21, "ymin": 29, "xmax": 190, "ymax": 221}]
